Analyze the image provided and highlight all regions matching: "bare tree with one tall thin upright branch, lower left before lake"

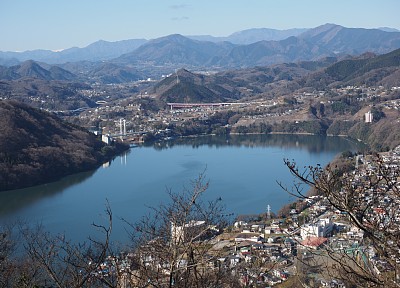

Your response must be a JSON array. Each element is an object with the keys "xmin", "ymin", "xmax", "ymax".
[{"xmin": 12, "ymin": 205, "xmax": 117, "ymax": 288}]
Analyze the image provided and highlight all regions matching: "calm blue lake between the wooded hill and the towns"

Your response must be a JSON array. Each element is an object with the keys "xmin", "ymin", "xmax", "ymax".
[{"xmin": 0, "ymin": 135, "xmax": 363, "ymax": 242}]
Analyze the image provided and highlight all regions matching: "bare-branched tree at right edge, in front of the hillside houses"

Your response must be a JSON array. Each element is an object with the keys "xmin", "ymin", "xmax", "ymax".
[{"xmin": 285, "ymin": 157, "xmax": 400, "ymax": 287}]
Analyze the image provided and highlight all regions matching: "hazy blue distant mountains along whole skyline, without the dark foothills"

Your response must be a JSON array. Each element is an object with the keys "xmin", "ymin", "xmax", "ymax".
[{"xmin": 0, "ymin": 24, "xmax": 400, "ymax": 67}]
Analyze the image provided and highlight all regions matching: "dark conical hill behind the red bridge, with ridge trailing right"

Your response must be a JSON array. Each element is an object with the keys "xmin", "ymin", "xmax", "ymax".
[{"xmin": 152, "ymin": 57, "xmax": 337, "ymax": 103}]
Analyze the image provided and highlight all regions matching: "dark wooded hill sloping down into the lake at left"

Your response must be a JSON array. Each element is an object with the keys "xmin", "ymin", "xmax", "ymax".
[{"xmin": 0, "ymin": 101, "xmax": 129, "ymax": 191}]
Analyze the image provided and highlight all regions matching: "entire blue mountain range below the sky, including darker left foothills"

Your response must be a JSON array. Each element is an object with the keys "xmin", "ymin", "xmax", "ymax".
[{"xmin": 0, "ymin": 24, "xmax": 400, "ymax": 84}]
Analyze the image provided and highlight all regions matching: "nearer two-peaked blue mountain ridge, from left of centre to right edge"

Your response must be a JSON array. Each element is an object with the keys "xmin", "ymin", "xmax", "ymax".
[{"xmin": 112, "ymin": 24, "xmax": 400, "ymax": 69}]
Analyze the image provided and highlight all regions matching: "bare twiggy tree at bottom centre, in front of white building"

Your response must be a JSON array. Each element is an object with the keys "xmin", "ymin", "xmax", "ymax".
[{"xmin": 123, "ymin": 175, "xmax": 236, "ymax": 287}]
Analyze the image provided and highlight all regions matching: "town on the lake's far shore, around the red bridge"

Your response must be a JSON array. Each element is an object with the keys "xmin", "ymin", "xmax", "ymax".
[{"xmin": 53, "ymin": 83, "xmax": 400, "ymax": 146}]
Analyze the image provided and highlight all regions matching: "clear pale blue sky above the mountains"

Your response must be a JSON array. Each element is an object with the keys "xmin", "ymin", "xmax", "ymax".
[{"xmin": 0, "ymin": 0, "xmax": 400, "ymax": 51}]
